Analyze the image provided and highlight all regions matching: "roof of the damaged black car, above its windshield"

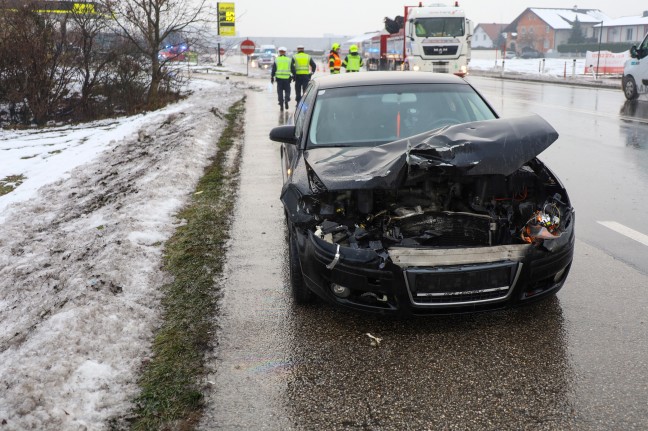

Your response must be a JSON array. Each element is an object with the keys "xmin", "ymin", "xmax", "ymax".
[{"xmin": 314, "ymin": 71, "xmax": 468, "ymax": 89}]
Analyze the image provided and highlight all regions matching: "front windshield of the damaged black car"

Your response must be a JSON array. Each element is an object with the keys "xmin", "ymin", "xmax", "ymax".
[{"xmin": 308, "ymin": 84, "xmax": 497, "ymax": 147}]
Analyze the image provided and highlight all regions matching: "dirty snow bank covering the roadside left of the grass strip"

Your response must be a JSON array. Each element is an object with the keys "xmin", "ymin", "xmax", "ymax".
[{"xmin": 0, "ymin": 76, "xmax": 243, "ymax": 430}]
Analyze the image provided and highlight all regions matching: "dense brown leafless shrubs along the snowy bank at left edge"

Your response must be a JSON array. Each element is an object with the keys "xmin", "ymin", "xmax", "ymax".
[{"xmin": 0, "ymin": 0, "xmax": 186, "ymax": 127}]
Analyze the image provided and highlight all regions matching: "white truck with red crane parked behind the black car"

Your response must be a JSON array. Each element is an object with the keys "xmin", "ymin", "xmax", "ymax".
[{"xmin": 362, "ymin": 1, "xmax": 473, "ymax": 76}]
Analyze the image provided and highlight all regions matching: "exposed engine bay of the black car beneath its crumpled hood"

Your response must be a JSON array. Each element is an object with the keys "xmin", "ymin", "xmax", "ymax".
[{"xmin": 300, "ymin": 159, "xmax": 573, "ymax": 251}]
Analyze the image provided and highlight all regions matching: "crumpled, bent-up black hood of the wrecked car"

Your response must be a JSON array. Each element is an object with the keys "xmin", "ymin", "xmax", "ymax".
[{"xmin": 298, "ymin": 115, "xmax": 558, "ymax": 194}]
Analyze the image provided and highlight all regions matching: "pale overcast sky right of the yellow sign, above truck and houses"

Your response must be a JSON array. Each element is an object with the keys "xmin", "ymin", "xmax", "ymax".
[{"xmin": 228, "ymin": 0, "xmax": 648, "ymax": 37}]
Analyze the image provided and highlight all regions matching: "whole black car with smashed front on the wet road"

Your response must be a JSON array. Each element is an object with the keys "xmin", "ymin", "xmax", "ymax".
[{"xmin": 270, "ymin": 72, "xmax": 575, "ymax": 315}]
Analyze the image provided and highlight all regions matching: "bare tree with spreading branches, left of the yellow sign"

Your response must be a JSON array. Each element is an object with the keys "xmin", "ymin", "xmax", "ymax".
[{"xmin": 101, "ymin": 0, "xmax": 206, "ymax": 109}]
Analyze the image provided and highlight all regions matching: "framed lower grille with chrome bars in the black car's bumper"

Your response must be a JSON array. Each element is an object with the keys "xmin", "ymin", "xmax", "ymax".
[{"xmin": 405, "ymin": 262, "xmax": 522, "ymax": 307}]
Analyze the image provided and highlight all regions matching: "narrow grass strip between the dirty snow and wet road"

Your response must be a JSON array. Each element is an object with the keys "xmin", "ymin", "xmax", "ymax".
[{"xmin": 126, "ymin": 99, "xmax": 245, "ymax": 430}]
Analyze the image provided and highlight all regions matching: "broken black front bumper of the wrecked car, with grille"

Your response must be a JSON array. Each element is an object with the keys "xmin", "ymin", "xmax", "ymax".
[{"xmin": 295, "ymin": 229, "xmax": 574, "ymax": 315}]
